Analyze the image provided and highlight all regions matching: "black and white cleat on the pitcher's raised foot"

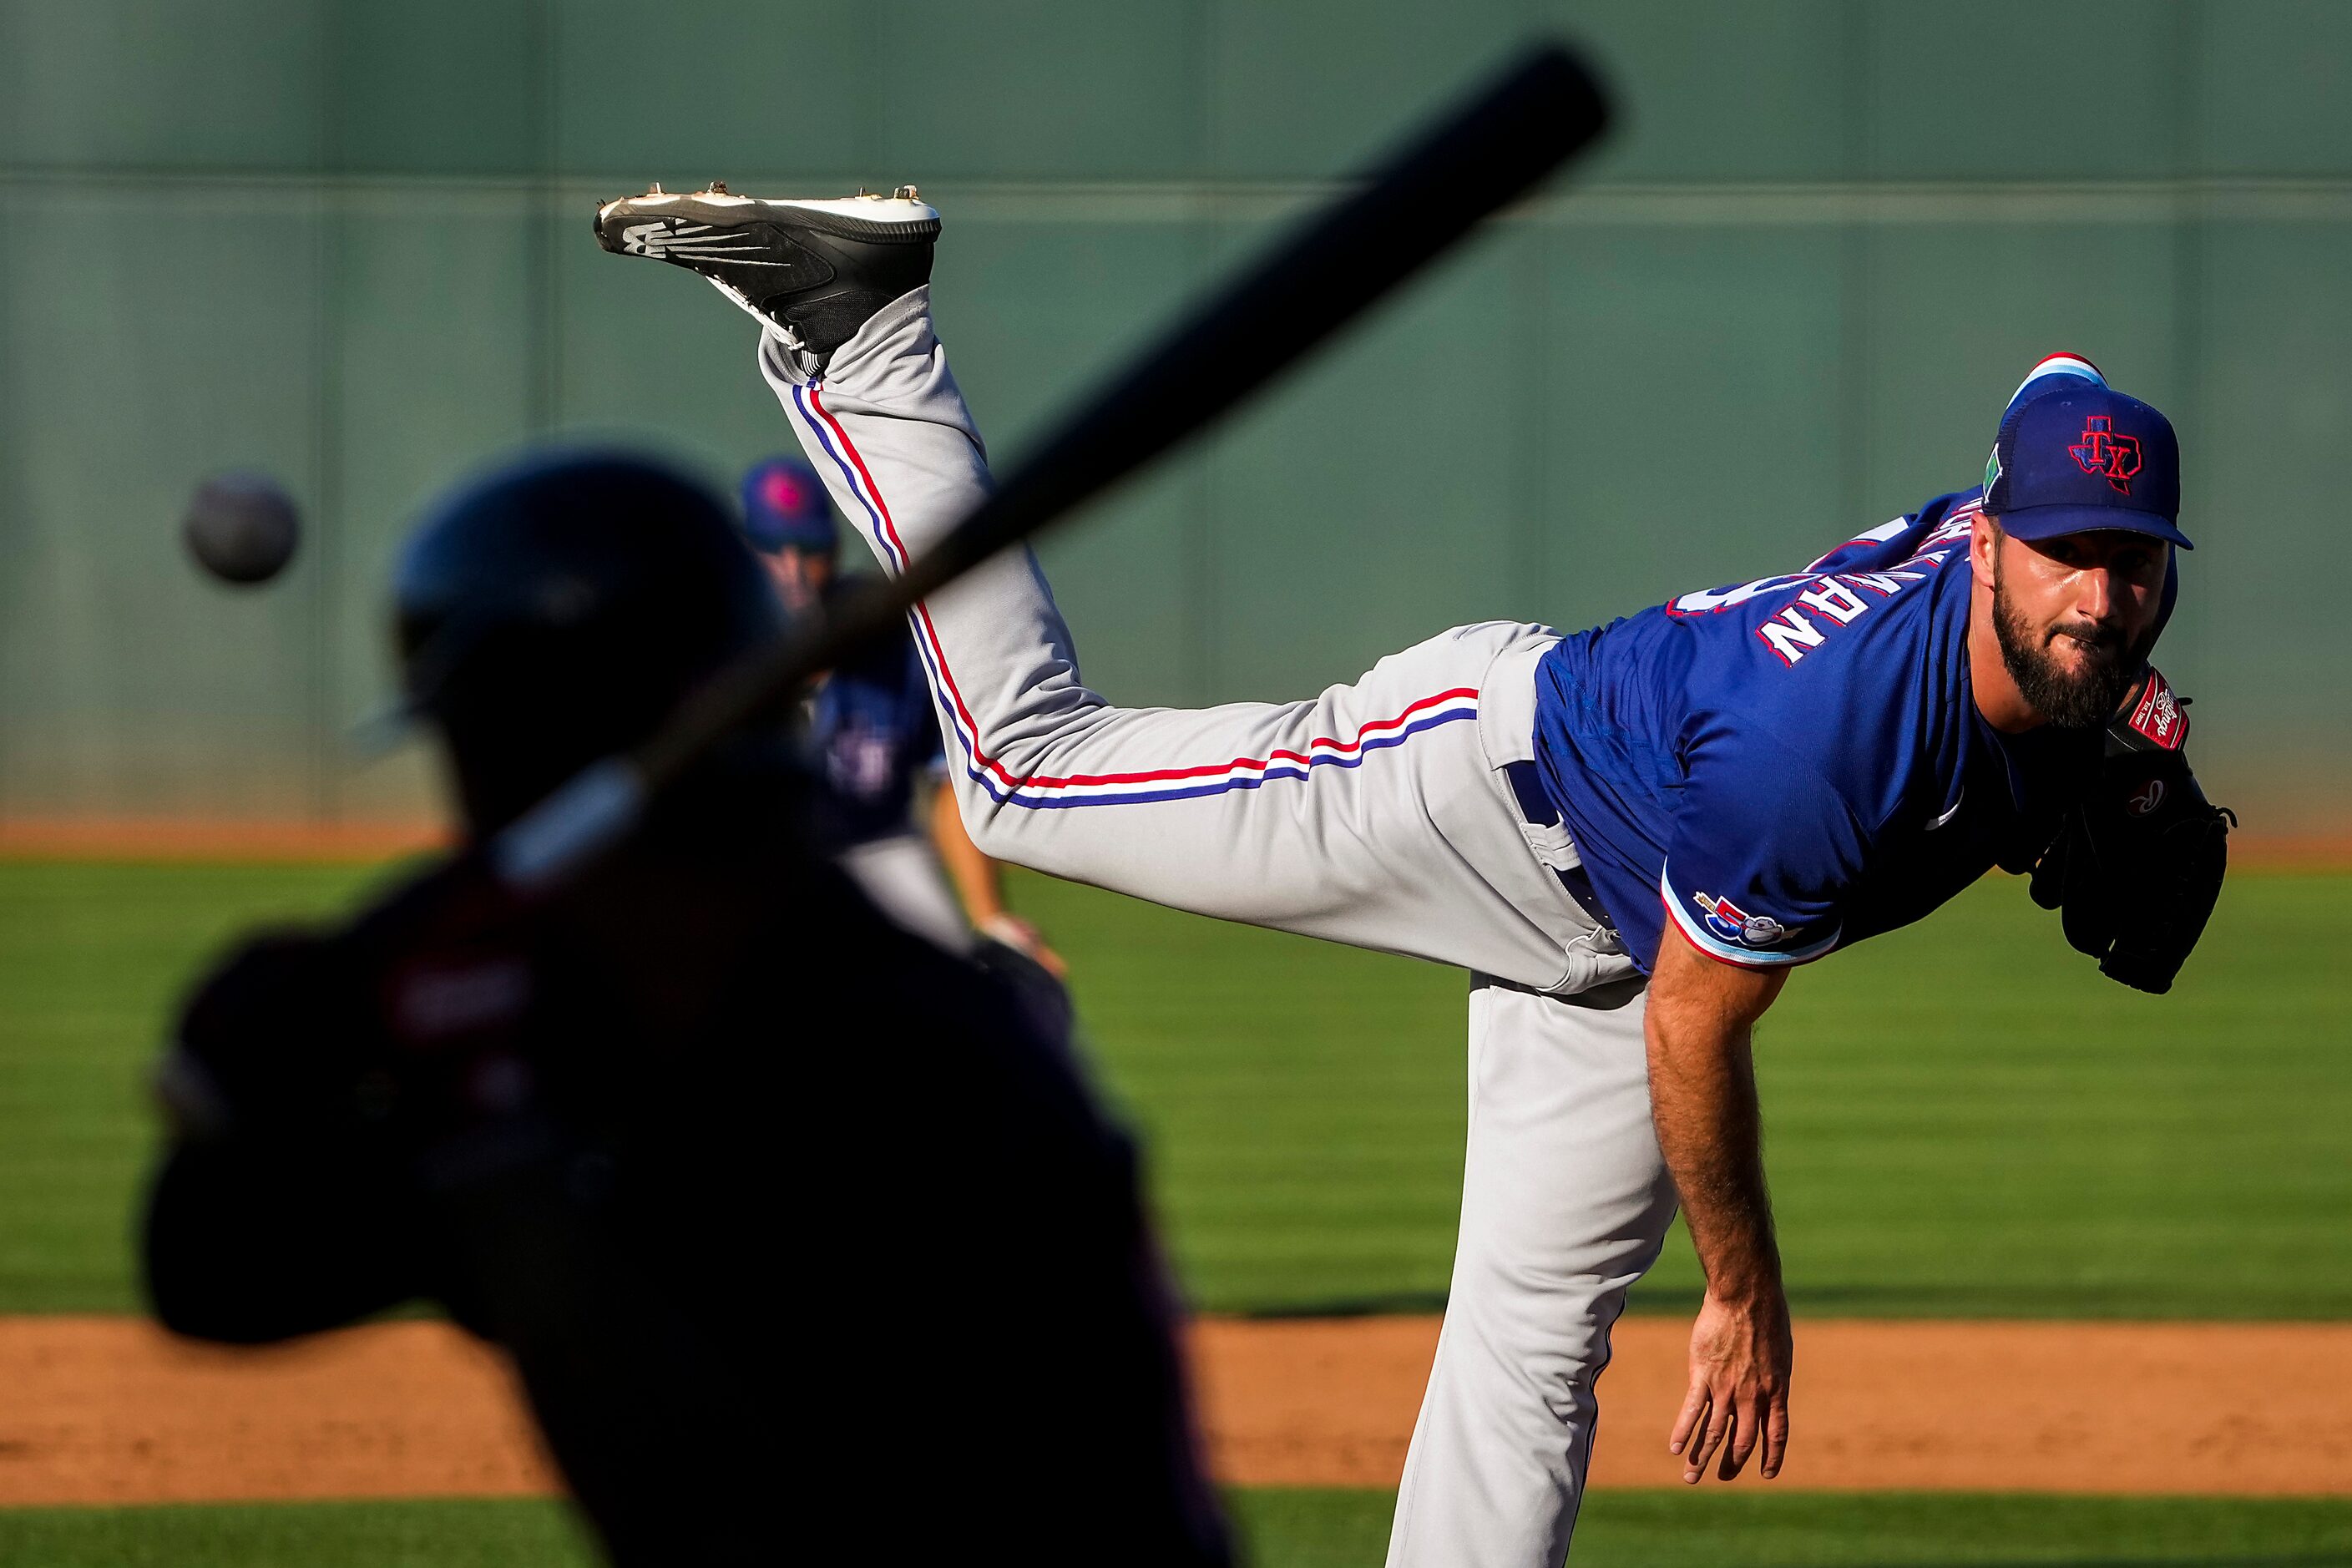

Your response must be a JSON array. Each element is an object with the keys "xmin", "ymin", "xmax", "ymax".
[{"xmin": 595, "ymin": 181, "xmax": 938, "ymax": 369}]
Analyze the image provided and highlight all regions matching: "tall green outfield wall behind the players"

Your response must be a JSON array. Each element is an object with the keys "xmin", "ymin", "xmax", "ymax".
[{"xmin": 0, "ymin": 0, "xmax": 2352, "ymax": 835}]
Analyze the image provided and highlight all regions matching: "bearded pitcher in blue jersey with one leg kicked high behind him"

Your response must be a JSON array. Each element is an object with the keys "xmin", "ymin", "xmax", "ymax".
[{"xmin": 598, "ymin": 188, "xmax": 2225, "ymax": 1568}]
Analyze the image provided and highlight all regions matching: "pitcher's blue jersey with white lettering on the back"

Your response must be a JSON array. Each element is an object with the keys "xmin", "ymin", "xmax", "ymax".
[{"xmin": 1536, "ymin": 489, "xmax": 2135, "ymax": 971}]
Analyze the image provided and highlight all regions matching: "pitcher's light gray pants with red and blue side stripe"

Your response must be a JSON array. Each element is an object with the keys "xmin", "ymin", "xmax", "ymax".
[{"xmin": 760, "ymin": 289, "xmax": 1675, "ymax": 1568}]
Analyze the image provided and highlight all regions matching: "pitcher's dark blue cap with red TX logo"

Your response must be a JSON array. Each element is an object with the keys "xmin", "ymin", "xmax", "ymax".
[{"xmin": 1985, "ymin": 355, "xmax": 2194, "ymax": 550}]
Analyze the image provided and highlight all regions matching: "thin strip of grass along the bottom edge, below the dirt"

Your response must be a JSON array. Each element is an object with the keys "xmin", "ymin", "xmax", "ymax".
[{"xmin": 13, "ymin": 1488, "xmax": 2352, "ymax": 1568}]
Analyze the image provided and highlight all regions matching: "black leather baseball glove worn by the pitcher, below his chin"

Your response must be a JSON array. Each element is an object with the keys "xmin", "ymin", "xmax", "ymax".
[{"xmin": 2032, "ymin": 670, "xmax": 2237, "ymax": 997}]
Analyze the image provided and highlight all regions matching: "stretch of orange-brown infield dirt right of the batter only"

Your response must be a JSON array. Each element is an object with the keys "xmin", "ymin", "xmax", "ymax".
[{"xmin": 1195, "ymin": 1319, "xmax": 2352, "ymax": 1498}]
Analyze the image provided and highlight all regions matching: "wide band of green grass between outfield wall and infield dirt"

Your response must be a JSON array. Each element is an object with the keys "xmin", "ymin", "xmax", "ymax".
[{"xmin": 0, "ymin": 862, "xmax": 2352, "ymax": 1319}]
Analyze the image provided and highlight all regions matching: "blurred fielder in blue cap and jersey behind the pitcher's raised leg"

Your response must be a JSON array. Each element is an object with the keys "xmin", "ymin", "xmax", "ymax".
[{"xmin": 743, "ymin": 456, "xmax": 1065, "ymax": 980}]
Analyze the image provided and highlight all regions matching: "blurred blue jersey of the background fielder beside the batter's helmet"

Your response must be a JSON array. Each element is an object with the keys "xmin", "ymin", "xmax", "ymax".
[{"xmin": 807, "ymin": 575, "xmax": 945, "ymax": 847}]
